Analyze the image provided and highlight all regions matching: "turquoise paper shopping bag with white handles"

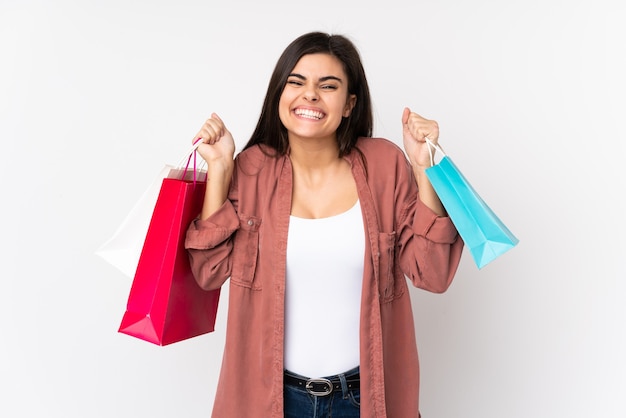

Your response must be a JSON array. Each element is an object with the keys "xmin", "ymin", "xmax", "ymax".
[{"xmin": 426, "ymin": 141, "xmax": 519, "ymax": 269}]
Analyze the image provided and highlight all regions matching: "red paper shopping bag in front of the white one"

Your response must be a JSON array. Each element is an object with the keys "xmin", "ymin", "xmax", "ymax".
[{"xmin": 119, "ymin": 178, "xmax": 219, "ymax": 345}]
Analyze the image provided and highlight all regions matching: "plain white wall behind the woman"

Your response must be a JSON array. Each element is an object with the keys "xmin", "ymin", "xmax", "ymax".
[{"xmin": 0, "ymin": 0, "xmax": 626, "ymax": 418}]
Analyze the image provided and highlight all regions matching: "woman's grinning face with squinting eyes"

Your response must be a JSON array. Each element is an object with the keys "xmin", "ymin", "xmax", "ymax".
[{"xmin": 278, "ymin": 54, "xmax": 356, "ymax": 142}]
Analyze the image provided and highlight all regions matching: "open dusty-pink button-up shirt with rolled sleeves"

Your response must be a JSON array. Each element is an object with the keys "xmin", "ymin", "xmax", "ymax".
[{"xmin": 185, "ymin": 138, "xmax": 463, "ymax": 418}]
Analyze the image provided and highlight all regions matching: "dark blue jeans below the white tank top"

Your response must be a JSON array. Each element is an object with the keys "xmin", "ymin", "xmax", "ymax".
[{"xmin": 284, "ymin": 367, "xmax": 361, "ymax": 418}]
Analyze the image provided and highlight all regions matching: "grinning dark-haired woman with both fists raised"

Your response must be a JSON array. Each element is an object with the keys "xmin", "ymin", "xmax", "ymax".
[{"xmin": 186, "ymin": 32, "xmax": 463, "ymax": 418}]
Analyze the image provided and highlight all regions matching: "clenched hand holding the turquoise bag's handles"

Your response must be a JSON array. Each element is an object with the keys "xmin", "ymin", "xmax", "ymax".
[{"xmin": 402, "ymin": 107, "xmax": 439, "ymax": 170}]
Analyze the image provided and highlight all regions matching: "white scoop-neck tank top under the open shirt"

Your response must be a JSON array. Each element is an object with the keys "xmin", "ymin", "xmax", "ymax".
[{"xmin": 284, "ymin": 201, "xmax": 365, "ymax": 377}]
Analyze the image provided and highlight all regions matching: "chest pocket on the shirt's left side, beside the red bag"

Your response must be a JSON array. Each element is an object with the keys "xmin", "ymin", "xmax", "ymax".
[{"xmin": 230, "ymin": 214, "xmax": 261, "ymax": 290}]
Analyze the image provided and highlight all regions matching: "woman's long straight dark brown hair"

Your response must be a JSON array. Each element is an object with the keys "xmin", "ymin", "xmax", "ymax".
[{"xmin": 244, "ymin": 32, "xmax": 373, "ymax": 157}]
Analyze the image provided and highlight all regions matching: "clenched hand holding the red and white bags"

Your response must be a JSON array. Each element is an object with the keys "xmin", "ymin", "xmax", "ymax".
[{"xmin": 192, "ymin": 113, "xmax": 235, "ymax": 166}]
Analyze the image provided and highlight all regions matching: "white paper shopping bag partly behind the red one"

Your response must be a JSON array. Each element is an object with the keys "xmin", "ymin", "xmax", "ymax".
[{"xmin": 95, "ymin": 146, "xmax": 204, "ymax": 279}]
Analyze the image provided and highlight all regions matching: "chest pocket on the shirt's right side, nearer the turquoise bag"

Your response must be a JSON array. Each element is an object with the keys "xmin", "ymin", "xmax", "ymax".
[{"xmin": 378, "ymin": 232, "xmax": 406, "ymax": 303}]
